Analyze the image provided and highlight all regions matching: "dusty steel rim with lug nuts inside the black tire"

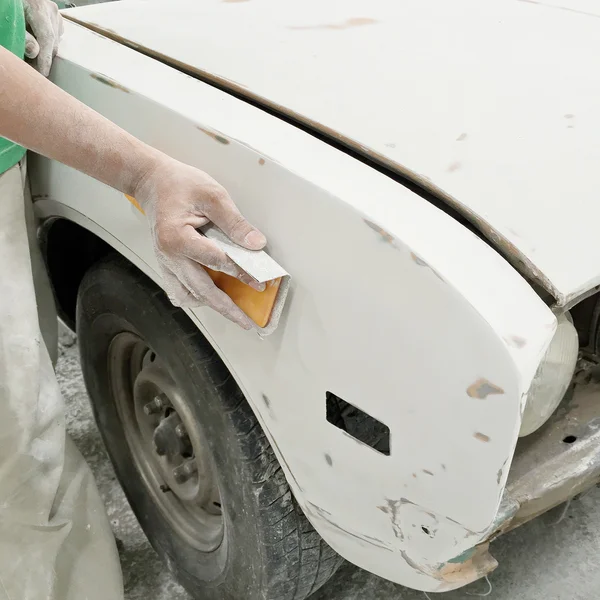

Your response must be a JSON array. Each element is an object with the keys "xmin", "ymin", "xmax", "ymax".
[{"xmin": 108, "ymin": 332, "xmax": 225, "ymax": 552}]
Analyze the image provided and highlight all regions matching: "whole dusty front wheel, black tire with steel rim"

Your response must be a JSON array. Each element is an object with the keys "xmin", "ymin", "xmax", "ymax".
[{"xmin": 77, "ymin": 255, "xmax": 342, "ymax": 600}]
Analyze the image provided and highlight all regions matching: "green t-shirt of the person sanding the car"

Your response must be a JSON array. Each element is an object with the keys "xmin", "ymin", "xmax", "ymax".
[{"xmin": 0, "ymin": 0, "xmax": 25, "ymax": 174}]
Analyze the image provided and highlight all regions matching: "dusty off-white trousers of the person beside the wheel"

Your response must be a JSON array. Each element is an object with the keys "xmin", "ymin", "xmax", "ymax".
[{"xmin": 0, "ymin": 163, "xmax": 123, "ymax": 600}]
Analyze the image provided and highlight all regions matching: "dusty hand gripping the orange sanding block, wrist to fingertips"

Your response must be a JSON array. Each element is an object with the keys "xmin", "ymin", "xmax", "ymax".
[{"xmin": 134, "ymin": 158, "xmax": 266, "ymax": 329}]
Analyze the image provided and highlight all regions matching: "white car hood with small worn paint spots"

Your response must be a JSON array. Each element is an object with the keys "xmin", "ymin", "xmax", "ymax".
[{"xmin": 66, "ymin": 0, "xmax": 600, "ymax": 305}]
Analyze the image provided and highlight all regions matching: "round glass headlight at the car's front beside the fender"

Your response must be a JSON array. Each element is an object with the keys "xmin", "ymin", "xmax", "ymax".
[{"xmin": 519, "ymin": 314, "xmax": 579, "ymax": 437}]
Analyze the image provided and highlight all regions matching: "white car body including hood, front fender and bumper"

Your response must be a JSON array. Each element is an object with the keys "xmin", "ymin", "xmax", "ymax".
[{"xmin": 32, "ymin": 0, "xmax": 600, "ymax": 591}]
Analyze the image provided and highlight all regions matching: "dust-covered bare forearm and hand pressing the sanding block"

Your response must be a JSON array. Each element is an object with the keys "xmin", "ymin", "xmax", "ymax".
[{"xmin": 0, "ymin": 47, "xmax": 266, "ymax": 329}]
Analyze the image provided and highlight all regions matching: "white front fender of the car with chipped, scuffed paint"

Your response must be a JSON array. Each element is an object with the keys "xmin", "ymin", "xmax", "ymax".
[{"xmin": 32, "ymin": 23, "xmax": 556, "ymax": 591}]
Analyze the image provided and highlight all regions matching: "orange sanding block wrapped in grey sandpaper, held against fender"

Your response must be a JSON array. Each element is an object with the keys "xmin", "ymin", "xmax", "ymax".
[{"xmin": 200, "ymin": 224, "xmax": 290, "ymax": 335}]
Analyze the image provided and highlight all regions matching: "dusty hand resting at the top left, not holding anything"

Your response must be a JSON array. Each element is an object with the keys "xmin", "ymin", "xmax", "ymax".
[{"xmin": 23, "ymin": 0, "xmax": 63, "ymax": 77}]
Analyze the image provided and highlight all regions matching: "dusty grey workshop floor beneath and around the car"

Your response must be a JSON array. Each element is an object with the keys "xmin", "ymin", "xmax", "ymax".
[{"xmin": 58, "ymin": 337, "xmax": 600, "ymax": 600}]
